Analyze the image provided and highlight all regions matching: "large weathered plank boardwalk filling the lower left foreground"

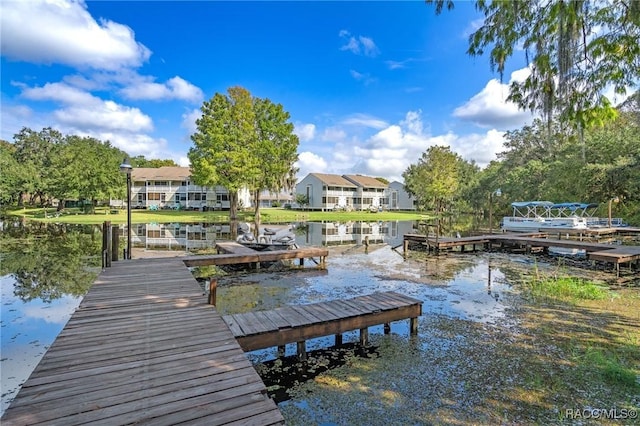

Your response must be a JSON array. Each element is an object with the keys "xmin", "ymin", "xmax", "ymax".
[{"xmin": 1, "ymin": 258, "xmax": 284, "ymax": 425}]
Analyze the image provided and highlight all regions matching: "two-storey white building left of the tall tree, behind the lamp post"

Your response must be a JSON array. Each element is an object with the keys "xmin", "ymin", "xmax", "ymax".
[{"xmin": 131, "ymin": 167, "xmax": 251, "ymax": 210}]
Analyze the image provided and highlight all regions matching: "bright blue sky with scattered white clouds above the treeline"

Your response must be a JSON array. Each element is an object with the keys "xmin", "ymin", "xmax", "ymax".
[{"xmin": 0, "ymin": 0, "xmax": 531, "ymax": 180}]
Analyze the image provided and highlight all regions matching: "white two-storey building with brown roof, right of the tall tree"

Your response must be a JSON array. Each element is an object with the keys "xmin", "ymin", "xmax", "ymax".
[{"xmin": 296, "ymin": 173, "xmax": 415, "ymax": 211}]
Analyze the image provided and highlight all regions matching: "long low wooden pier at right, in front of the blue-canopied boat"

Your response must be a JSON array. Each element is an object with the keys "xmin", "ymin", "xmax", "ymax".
[{"xmin": 404, "ymin": 228, "xmax": 640, "ymax": 276}]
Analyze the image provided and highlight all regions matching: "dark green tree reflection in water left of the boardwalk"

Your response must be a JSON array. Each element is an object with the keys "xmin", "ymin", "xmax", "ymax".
[{"xmin": 0, "ymin": 222, "xmax": 102, "ymax": 302}]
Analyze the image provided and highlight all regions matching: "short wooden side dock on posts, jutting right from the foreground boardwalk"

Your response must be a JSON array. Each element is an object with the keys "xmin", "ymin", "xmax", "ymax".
[{"xmin": 223, "ymin": 291, "xmax": 422, "ymax": 358}]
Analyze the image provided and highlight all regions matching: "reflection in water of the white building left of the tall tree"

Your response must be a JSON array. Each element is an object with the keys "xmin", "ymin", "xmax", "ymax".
[{"xmin": 131, "ymin": 223, "xmax": 231, "ymax": 251}]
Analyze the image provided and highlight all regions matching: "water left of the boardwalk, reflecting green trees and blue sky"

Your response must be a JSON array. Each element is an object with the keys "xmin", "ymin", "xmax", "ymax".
[{"xmin": 0, "ymin": 220, "xmax": 102, "ymax": 412}]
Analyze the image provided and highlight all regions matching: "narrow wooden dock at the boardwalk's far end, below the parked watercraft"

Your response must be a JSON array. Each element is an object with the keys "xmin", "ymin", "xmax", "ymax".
[{"xmin": 183, "ymin": 241, "xmax": 329, "ymax": 268}]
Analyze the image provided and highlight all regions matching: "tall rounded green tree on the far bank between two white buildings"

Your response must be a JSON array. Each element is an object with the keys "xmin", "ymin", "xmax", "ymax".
[{"xmin": 189, "ymin": 87, "xmax": 298, "ymax": 220}]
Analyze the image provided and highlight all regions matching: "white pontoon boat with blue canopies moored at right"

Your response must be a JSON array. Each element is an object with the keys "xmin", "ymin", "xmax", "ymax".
[{"xmin": 502, "ymin": 201, "xmax": 597, "ymax": 232}]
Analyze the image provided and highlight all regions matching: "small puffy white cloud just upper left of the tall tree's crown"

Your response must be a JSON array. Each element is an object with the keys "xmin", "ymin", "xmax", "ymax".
[{"xmin": 120, "ymin": 76, "xmax": 204, "ymax": 103}]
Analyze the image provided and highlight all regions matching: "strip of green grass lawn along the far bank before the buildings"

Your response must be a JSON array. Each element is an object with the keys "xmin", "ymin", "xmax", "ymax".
[{"xmin": 6, "ymin": 207, "xmax": 426, "ymax": 224}]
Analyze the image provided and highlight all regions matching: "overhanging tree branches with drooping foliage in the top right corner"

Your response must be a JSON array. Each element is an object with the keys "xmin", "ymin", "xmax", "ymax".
[{"xmin": 426, "ymin": 0, "xmax": 640, "ymax": 136}]
